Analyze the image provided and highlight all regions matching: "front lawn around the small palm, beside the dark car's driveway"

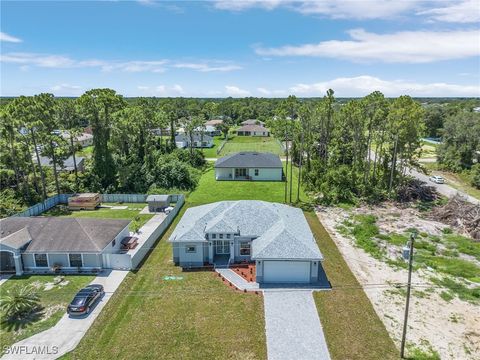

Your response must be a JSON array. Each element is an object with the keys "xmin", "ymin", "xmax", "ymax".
[{"xmin": 0, "ymin": 275, "xmax": 95, "ymax": 353}]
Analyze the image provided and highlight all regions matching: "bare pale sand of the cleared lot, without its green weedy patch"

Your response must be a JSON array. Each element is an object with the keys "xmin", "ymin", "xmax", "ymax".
[{"xmin": 317, "ymin": 205, "xmax": 480, "ymax": 359}]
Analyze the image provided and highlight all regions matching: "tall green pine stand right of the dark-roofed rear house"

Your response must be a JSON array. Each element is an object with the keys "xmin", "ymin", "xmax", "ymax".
[{"xmin": 269, "ymin": 90, "xmax": 425, "ymax": 204}]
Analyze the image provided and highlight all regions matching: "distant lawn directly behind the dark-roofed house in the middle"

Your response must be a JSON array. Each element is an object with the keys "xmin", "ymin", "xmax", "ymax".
[{"xmin": 220, "ymin": 136, "xmax": 284, "ymax": 156}]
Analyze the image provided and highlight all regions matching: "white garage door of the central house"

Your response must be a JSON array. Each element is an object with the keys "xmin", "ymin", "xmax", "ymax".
[{"xmin": 263, "ymin": 261, "xmax": 310, "ymax": 283}]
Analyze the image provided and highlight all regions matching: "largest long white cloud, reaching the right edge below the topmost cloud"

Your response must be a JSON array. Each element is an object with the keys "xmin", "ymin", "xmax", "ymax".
[{"xmin": 256, "ymin": 29, "xmax": 480, "ymax": 63}]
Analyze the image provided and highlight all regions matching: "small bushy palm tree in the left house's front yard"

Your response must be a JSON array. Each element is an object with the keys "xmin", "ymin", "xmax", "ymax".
[{"xmin": 0, "ymin": 285, "xmax": 40, "ymax": 319}]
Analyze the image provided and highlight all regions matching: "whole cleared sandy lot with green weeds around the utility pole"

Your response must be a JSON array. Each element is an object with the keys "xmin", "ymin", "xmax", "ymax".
[{"xmin": 317, "ymin": 204, "xmax": 480, "ymax": 359}]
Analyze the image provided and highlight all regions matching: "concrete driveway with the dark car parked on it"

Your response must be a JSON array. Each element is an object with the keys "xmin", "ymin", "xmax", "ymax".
[{"xmin": 2, "ymin": 270, "xmax": 128, "ymax": 360}]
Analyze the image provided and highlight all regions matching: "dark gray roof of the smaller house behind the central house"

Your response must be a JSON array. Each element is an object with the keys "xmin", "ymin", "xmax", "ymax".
[{"xmin": 215, "ymin": 151, "xmax": 282, "ymax": 168}]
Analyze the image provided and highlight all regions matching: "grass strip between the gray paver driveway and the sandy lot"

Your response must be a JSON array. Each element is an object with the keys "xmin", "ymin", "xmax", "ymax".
[{"xmin": 305, "ymin": 212, "xmax": 399, "ymax": 360}]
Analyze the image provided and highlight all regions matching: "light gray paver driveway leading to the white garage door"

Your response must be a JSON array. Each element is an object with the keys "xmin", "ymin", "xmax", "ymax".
[{"xmin": 263, "ymin": 290, "xmax": 330, "ymax": 360}]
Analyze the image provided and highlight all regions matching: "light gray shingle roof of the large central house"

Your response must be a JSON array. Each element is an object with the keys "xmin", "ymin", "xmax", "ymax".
[{"xmin": 169, "ymin": 200, "xmax": 323, "ymax": 260}]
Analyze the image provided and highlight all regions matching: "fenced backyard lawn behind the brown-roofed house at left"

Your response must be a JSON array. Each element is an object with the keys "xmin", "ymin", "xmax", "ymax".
[{"xmin": 42, "ymin": 203, "xmax": 153, "ymax": 229}]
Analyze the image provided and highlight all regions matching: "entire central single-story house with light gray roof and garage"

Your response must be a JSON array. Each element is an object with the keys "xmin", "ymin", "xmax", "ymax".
[{"xmin": 168, "ymin": 200, "xmax": 323, "ymax": 283}]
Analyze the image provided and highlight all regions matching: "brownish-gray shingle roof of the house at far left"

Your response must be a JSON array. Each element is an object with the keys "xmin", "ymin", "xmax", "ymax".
[{"xmin": 0, "ymin": 217, "xmax": 130, "ymax": 253}]
